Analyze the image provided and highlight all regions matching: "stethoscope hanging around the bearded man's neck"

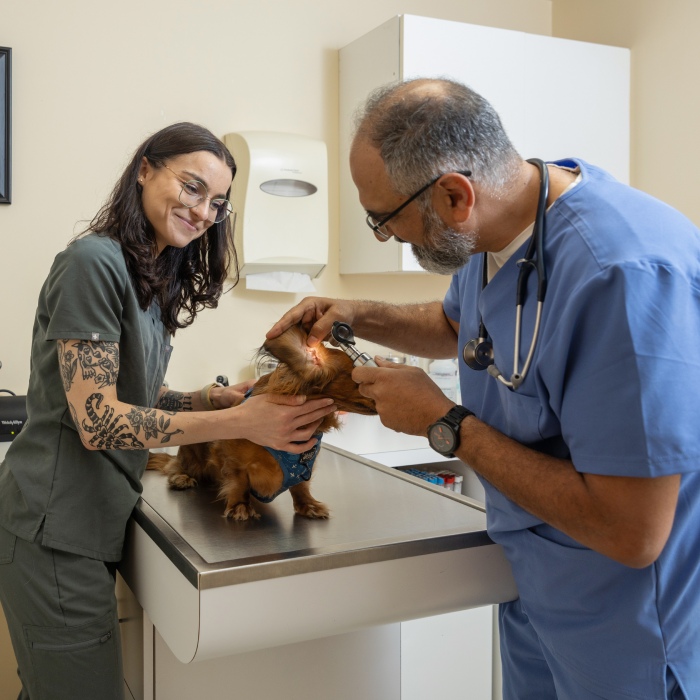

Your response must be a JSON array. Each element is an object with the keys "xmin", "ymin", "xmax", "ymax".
[{"xmin": 462, "ymin": 158, "xmax": 549, "ymax": 391}]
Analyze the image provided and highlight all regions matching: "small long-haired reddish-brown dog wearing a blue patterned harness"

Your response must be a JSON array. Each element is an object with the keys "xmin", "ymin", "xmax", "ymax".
[{"xmin": 148, "ymin": 326, "xmax": 376, "ymax": 520}]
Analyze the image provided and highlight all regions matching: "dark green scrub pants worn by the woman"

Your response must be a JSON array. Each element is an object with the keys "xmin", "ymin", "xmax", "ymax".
[{"xmin": 0, "ymin": 528, "xmax": 124, "ymax": 700}]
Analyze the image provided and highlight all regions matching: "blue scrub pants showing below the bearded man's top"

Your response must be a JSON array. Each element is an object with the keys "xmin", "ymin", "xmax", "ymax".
[{"xmin": 498, "ymin": 600, "xmax": 689, "ymax": 700}]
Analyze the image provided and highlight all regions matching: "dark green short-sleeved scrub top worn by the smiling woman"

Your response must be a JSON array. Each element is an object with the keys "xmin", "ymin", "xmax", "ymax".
[{"xmin": 0, "ymin": 234, "xmax": 171, "ymax": 561}]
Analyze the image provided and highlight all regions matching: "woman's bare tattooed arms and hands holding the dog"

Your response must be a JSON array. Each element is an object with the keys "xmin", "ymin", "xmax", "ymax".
[{"xmin": 56, "ymin": 339, "xmax": 335, "ymax": 453}]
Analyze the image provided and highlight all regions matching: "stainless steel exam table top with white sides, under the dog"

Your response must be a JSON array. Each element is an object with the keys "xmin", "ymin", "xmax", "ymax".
[{"xmin": 120, "ymin": 446, "xmax": 517, "ymax": 663}]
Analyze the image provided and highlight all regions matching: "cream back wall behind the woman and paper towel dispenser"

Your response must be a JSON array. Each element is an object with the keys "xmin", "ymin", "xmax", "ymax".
[{"xmin": 0, "ymin": 0, "xmax": 551, "ymax": 393}]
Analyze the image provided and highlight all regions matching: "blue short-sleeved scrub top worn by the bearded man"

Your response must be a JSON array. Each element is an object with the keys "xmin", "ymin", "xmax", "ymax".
[{"xmin": 444, "ymin": 159, "xmax": 700, "ymax": 698}]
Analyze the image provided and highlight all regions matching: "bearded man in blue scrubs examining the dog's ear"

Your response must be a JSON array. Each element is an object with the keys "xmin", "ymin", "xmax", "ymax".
[{"xmin": 269, "ymin": 80, "xmax": 700, "ymax": 700}]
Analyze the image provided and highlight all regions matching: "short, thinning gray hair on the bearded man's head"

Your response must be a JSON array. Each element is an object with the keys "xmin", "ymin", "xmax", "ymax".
[{"xmin": 355, "ymin": 78, "xmax": 521, "ymax": 200}]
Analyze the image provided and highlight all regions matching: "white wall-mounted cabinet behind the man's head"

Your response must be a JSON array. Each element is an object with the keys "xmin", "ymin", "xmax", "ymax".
[{"xmin": 339, "ymin": 15, "xmax": 630, "ymax": 274}]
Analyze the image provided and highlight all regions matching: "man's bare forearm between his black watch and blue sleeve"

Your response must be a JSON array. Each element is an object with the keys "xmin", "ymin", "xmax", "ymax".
[{"xmin": 456, "ymin": 417, "xmax": 681, "ymax": 568}]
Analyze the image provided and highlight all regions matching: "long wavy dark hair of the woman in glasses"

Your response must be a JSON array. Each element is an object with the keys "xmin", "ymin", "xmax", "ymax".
[{"xmin": 81, "ymin": 122, "xmax": 238, "ymax": 334}]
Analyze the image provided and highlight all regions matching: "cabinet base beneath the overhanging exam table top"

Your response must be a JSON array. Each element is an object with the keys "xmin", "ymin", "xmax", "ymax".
[{"xmin": 117, "ymin": 577, "xmax": 493, "ymax": 700}]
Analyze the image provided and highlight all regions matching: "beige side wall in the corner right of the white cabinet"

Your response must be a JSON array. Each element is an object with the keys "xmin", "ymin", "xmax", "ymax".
[{"xmin": 552, "ymin": 0, "xmax": 700, "ymax": 224}]
